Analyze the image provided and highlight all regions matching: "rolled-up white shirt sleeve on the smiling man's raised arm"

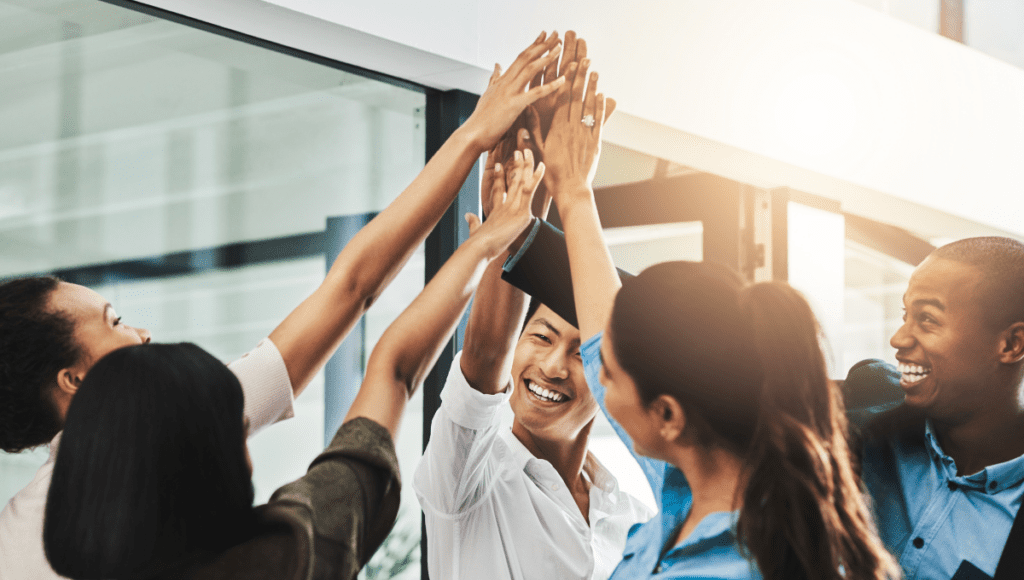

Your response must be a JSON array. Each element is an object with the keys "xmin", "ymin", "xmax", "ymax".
[{"xmin": 413, "ymin": 353, "xmax": 512, "ymax": 517}]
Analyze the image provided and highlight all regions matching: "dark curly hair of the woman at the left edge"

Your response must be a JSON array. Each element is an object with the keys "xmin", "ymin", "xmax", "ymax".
[{"xmin": 0, "ymin": 276, "xmax": 81, "ymax": 453}]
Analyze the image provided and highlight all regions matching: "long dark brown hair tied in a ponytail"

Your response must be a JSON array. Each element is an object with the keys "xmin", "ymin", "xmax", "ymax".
[{"xmin": 610, "ymin": 261, "xmax": 898, "ymax": 580}]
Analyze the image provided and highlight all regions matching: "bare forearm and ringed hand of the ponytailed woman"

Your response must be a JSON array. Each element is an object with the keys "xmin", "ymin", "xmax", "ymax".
[{"xmin": 543, "ymin": 58, "xmax": 622, "ymax": 341}]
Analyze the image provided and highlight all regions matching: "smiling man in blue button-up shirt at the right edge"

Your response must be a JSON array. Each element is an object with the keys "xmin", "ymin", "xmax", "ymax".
[{"xmin": 851, "ymin": 238, "xmax": 1024, "ymax": 580}]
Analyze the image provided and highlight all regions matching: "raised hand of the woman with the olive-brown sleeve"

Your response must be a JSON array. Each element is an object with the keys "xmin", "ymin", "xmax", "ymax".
[{"xmin": 466, "ymin": 149, "xmax": 544, "ymax": 257}]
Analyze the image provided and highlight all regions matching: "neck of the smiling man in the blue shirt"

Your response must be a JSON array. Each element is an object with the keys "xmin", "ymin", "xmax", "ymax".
[{"xmin": 932, "ymin": 388, "xmax": 1024, "ymax": 475}]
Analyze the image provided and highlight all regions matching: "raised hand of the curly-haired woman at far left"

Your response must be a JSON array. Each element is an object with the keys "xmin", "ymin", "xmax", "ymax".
[{"xmin": 463, "ymin": 33, "xmax": 565, "ymax": 153}]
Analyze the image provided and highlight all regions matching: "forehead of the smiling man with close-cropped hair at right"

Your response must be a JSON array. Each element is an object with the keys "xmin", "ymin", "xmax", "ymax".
[{"xmin": 903, "ymin": 258, "xmax": 984, "ymax": 309}]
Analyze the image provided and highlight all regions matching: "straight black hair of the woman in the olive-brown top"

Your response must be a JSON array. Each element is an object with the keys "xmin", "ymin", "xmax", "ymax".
[{"xmin": 43, "ymin": 343, "xmax": 255, "ymax": 579}]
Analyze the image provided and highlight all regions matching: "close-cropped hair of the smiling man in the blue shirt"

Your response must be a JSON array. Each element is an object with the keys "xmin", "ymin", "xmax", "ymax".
[{"xmin": 931, "ymin": 236, "xmax": 1024, "ymax": 330}]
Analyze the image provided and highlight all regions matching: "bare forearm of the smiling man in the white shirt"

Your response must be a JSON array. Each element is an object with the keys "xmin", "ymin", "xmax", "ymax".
[{"xmin": 462, "ymin": 259, "xmax": 526, "ymax": 395}]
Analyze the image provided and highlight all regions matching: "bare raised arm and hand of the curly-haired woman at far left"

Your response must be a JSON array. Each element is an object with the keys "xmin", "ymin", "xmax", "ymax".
[{"xmin": 270, "ymin": 33, "xmax": 562, "ymax": 395}]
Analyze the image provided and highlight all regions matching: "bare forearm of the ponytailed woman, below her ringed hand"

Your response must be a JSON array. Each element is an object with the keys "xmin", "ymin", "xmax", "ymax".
[{"xmin": 558, "ymin": 187, "xmax": 622, "ymax": 340}]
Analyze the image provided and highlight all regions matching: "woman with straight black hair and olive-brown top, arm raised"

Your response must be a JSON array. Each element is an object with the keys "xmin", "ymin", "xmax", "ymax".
[{"xmin": 43, "ymin": 135, "xmax": 544, "ymax": 580}]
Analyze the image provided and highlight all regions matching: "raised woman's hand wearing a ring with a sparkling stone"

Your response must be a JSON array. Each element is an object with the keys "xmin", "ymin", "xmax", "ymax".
[{"xmin": 538, "ymin": 58, "xmax": 610, "ymax": 207}]
